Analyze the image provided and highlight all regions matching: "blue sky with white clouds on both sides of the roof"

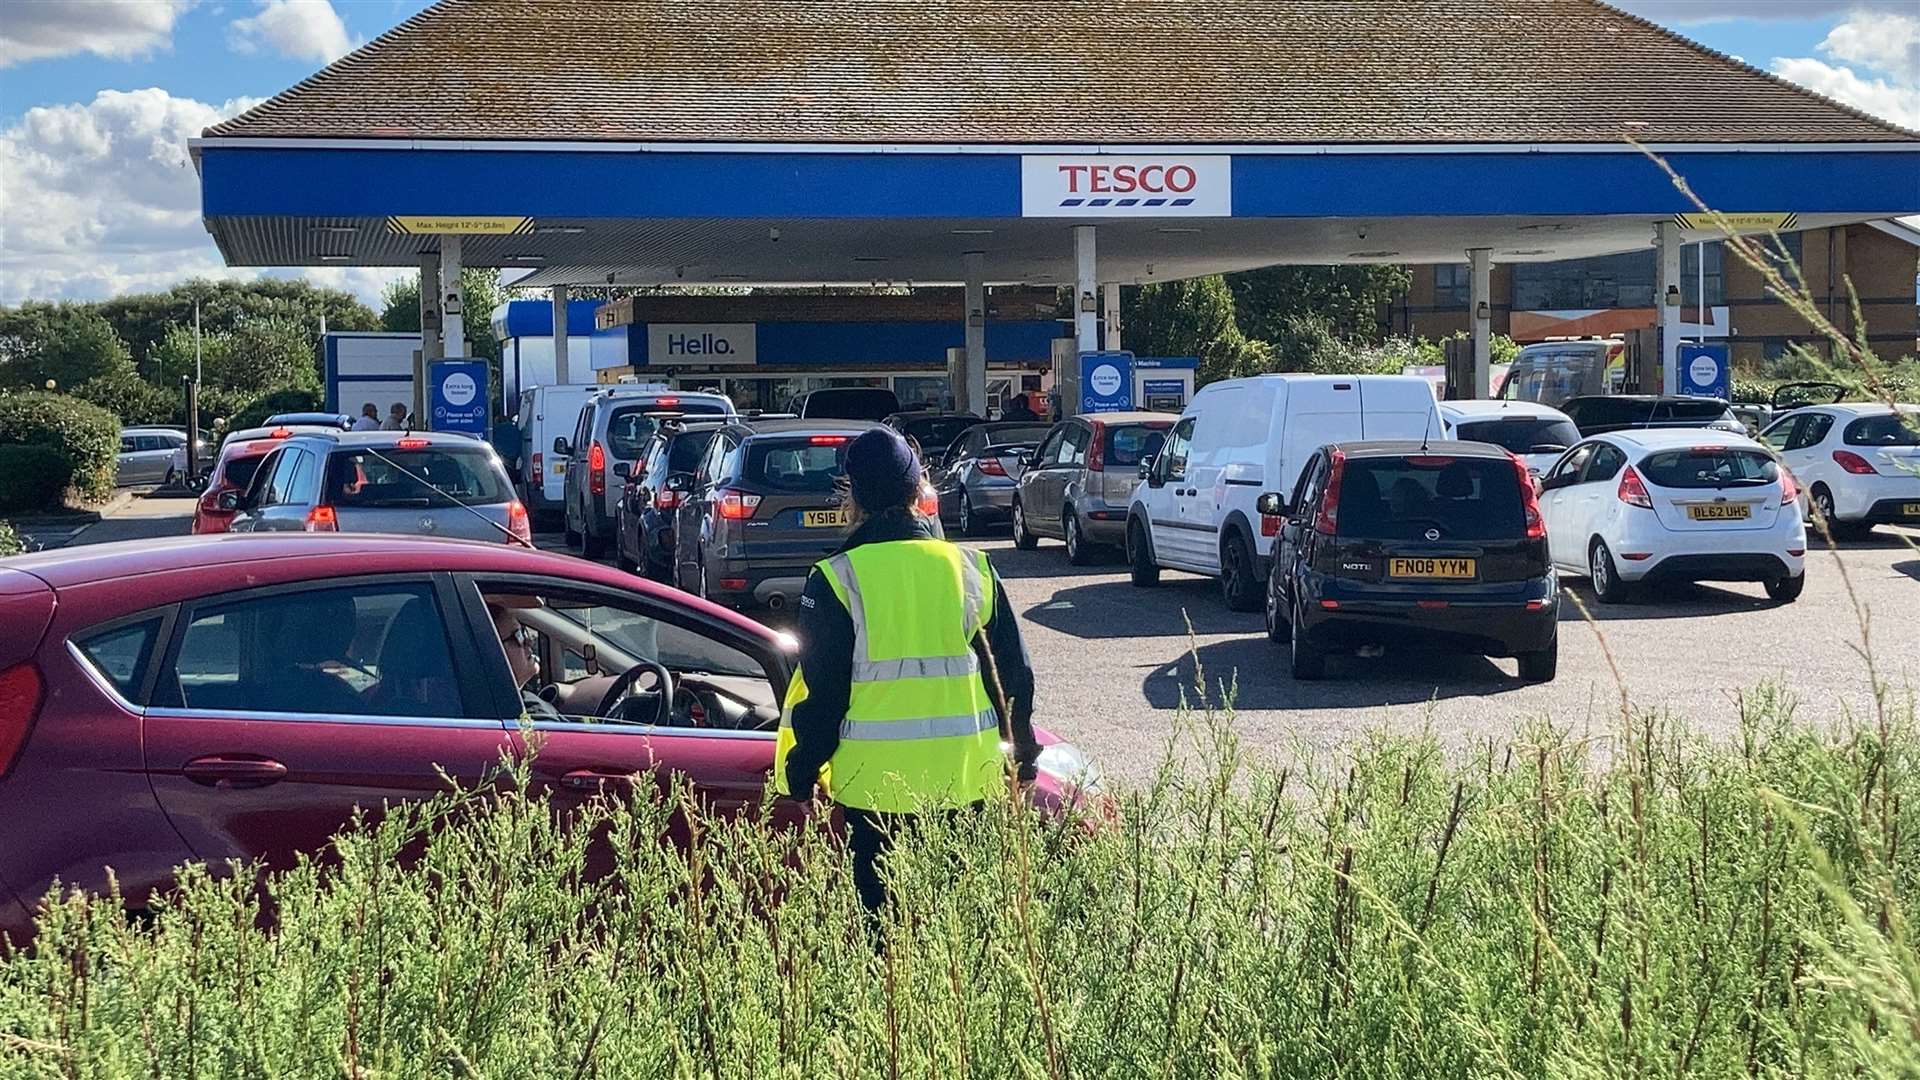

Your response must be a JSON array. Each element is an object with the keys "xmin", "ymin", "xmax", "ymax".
[{"xmin": 0, "ymin": 0, "xmax": 1920, "ymax": 304}]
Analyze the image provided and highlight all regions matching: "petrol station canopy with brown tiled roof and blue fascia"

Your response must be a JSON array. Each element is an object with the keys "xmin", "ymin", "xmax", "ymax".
[{"xmin": 194, "ymin": 0, "xmax": 1920, "ymax": 284}]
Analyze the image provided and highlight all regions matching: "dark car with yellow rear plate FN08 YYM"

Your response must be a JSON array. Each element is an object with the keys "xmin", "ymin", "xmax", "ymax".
[{"xmin": 1260, "ymin": 442, "xmax": 1559, "ymax": 682}]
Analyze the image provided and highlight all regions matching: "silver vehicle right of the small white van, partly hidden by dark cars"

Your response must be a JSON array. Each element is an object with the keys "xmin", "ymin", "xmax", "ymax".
[{"xmin": 553, "ymin": 386, "xmax": 733, "ymax": 557}]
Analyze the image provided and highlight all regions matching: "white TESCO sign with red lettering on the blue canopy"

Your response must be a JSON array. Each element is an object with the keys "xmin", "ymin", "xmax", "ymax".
[{"xmin": 1020, "ymin": 154, "xmax": 1233, "ymax": 217}]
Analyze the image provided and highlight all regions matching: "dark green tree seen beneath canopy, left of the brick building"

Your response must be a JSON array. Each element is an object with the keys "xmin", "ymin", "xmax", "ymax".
[{"xmin": 1227, "ymin": 265, "xmax": 1413, "ymax": 342}]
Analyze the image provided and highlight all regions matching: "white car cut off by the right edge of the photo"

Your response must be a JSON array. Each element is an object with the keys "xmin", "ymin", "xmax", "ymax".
[{"xmin": 1761, "ymin": 404, "xmax": 1920, "ymax": 538}]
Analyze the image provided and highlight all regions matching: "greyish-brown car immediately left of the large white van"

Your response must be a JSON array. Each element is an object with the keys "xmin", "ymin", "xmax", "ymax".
[{"xmin": 1012, "ymin": 413, "xmax": 1173, "ymax": 567}]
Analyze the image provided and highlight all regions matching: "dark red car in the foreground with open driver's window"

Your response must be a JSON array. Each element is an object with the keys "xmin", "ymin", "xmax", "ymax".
[{"xmin": 0, "ymin": 532, "xmax": 1089, "ymax": 944}]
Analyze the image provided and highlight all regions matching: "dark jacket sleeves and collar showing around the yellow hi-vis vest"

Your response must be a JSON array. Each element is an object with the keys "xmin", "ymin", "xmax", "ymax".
[{"xmin": 787, "ymin": 507, "xmax": 1041, "ymax": 799}]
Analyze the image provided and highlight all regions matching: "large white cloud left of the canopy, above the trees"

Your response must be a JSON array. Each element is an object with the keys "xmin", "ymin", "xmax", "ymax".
[{"xmin": 0, "ymin": 88, "xmax": 405, "ymax": 304}]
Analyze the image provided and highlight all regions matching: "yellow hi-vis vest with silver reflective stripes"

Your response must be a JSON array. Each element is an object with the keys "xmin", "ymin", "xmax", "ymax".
[{"xmin": 774, "ymin": 540, "xmax": 1006, "ymax": 813}]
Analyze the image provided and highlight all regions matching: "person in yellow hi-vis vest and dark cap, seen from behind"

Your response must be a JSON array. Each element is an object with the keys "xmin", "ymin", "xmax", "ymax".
[{"xmin": 774, "ymin": 429, "xmax": 1041, "ymax": 919}]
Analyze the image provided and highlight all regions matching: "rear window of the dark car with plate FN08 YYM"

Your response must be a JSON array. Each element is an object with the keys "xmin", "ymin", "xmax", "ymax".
[{"xmin": 1338, "ymin": 454, "xmax": 1526, "ymax": 540}]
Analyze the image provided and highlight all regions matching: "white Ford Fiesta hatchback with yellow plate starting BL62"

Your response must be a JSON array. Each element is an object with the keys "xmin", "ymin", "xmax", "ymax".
[{"xmin": 1540, "ymin": 429, "xmax": 1807, "ymax": 603}]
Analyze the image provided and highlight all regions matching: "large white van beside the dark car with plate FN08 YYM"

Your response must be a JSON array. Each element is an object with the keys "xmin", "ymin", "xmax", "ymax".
[{"xmin": 1127, "ymin": 375, "xmax": 1446, "ymax": 611}]
